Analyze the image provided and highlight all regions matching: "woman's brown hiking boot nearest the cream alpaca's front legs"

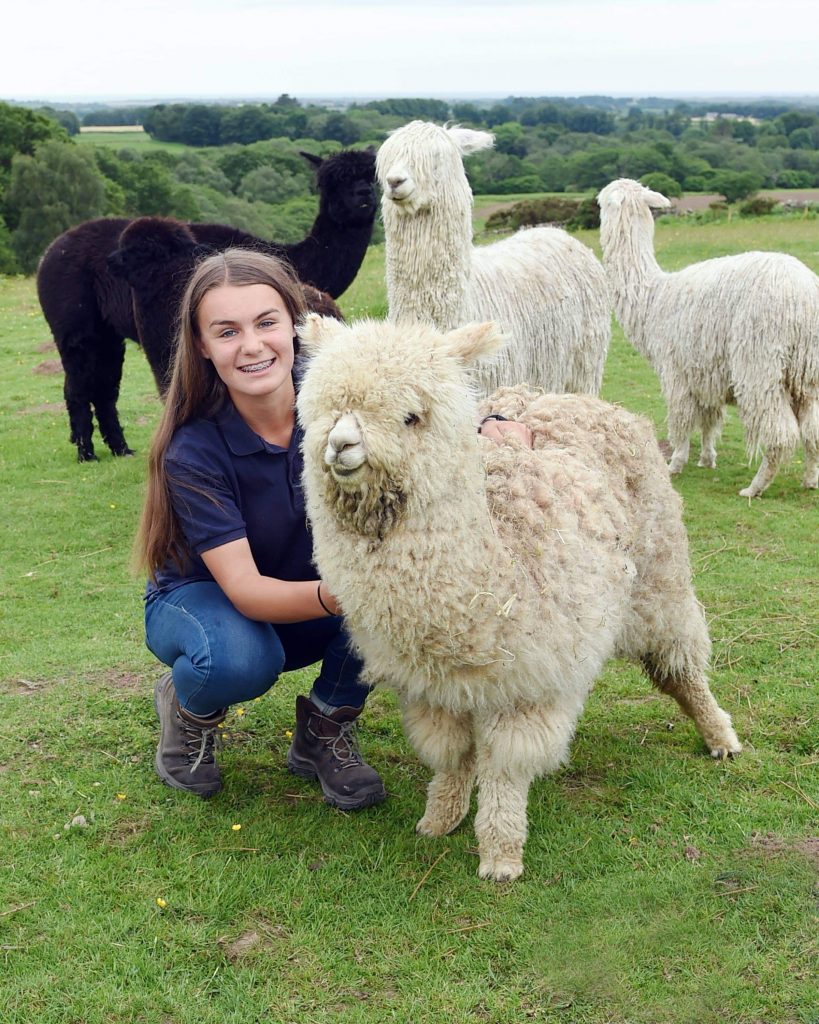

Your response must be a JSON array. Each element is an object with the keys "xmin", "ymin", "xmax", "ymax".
[{"xmin": 288, "ymin": 696, "xmax": 387, "ymax": 811}]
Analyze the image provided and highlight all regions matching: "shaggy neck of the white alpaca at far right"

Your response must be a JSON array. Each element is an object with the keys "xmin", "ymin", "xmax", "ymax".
[{"xmin": 600, "ymin": 205, "xmax": 665, "ymax": 359}]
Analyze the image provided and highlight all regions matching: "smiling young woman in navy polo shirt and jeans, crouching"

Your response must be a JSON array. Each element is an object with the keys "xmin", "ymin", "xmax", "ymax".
[{"xmin": 137, "ymin": 249, "xmax": 525, "ymax": 810}]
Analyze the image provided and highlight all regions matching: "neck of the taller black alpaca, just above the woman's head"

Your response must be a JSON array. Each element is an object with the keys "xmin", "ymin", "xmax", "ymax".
[{"xmin": 283, "ymin": 210, "xmax": 373, "ymax": 299}]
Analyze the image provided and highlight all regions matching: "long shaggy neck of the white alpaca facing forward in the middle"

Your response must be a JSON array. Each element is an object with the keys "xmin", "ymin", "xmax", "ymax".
[{"xmin": 384, "ymin": 197, "xmax": 472, "ymax": 331}]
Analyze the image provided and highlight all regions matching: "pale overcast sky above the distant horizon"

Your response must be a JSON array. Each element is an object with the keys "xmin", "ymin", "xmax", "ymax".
[{"xmin": 0, "ymin": 0, "xmax": 819, "ymax": 100}]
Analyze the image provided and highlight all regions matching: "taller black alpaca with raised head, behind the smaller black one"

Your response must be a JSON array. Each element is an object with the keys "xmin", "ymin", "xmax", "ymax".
[{"xmin": 37, "ymin": 150, "xmax": 377, "ymax": 462}]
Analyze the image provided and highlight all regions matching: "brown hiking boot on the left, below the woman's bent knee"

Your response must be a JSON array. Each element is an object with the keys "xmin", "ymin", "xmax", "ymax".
[{"xmin": 154, "ymin": 672, "xmax": 227, "ymax": 800}]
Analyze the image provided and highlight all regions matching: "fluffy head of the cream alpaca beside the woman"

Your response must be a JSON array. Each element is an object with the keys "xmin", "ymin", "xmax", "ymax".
[{"xmin": 298, "ymin": 315, "xmax": 503, "ymax": 538}]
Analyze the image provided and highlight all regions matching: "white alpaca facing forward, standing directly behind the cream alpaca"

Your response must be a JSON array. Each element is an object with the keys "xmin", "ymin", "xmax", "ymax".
[{"xmin": 376, "ymin": 121, "xmax": 611, "ymax": 394}]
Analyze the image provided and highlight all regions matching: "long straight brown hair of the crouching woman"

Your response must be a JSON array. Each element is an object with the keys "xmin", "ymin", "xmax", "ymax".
[{"xmin": 134, "ymin": 249, "xmax": 304, "ymax": 580}]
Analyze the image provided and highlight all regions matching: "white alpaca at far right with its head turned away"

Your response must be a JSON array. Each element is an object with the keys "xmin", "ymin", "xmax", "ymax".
[{"xmin": 598, "ymin": 178, "xmax": 819, "ymax": 498}]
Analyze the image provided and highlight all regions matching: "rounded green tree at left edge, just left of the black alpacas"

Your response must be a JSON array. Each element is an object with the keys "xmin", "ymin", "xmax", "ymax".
[{"xmin": 6, "ymin": 141, "xmax": 105, "ymax": 273}]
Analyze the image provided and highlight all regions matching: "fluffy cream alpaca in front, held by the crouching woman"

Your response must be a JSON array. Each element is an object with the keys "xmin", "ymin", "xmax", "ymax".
[{"xmin": 298, "ymin": 314, "xmax": 741, "ymax": 881}]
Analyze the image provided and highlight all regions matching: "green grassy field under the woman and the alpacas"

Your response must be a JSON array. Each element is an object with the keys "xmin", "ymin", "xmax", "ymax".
[{"xmin": 0, "ymin": 211, "xmax": 819, "ymax": 1024}]
